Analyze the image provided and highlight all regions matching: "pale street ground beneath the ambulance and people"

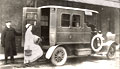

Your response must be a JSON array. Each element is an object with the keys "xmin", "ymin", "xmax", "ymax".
[{"xmin": 0, "ymin": 52, "xmax": 120, "ymax": 69}]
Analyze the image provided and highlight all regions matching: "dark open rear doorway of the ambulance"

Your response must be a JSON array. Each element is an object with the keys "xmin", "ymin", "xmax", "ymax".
[{"xmin": 40, "ymin": 8, "xmax": 50, "ymax": 45}]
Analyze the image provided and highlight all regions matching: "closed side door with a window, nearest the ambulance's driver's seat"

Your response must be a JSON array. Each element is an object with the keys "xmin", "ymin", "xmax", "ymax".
[{"xmin": 69, "ymin": 11, "xmax": 84, "ymax": 44}]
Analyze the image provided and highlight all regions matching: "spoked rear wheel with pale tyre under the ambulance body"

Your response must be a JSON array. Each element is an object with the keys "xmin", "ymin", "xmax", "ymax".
[{"xmin": 51, "ymin": 47, "xmax": 67, "ymax": 65}]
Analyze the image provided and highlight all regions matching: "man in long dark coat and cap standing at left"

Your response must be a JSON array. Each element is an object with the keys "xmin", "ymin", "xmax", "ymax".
[{"xmin": 1, "ymin": 21, "xmax": 18, "ymax": 64}]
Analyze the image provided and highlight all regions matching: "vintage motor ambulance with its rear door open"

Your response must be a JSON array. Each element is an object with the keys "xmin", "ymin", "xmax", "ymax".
[{"xmin": 22, "ymin": 6, "xmax": 116, "ymax": 65}]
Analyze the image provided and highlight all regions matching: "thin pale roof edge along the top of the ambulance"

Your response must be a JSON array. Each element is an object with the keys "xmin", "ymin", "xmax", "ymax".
[{"xmin": 23, "ymin": 5, "xmax": 99, "ymax": 13}]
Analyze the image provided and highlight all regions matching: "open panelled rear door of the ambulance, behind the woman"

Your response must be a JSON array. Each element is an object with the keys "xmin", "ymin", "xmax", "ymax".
[{"xmin": 22, "ymin": 7, "xmax": 37, "ymax": 46}]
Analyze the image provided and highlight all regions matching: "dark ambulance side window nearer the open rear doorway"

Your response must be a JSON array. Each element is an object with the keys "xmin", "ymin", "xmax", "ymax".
[{"xmin": 61, "ymin": 14, "xmax": 70, "ymax": 27}]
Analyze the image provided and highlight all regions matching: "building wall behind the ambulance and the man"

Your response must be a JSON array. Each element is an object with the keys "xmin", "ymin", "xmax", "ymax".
[{"xmin": 0, "ymin": 0, "xmax": 120, "ymax": 53}]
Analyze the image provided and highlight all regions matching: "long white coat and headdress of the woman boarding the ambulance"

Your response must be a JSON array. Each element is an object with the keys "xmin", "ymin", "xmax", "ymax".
[{"xmin": 24, "ymin": 26, "xmax": 43, "ymax": 63}]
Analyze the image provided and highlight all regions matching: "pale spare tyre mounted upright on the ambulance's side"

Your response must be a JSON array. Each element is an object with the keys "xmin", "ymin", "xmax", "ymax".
[{"xmin": 91, "ymin": 35, "xmax": 103, "ymax": 52}]
